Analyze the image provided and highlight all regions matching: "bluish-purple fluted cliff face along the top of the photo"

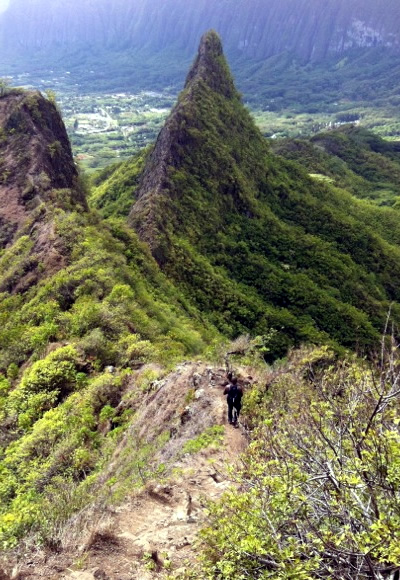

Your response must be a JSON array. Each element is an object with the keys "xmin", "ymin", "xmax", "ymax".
[{"xmin": 0, "ymin": 0, "xmax": 400, "ymax": 61}]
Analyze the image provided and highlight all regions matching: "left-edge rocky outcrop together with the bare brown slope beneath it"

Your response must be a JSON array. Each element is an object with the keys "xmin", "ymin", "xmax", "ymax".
[{"xmin": 0, "ymin": 90, "xmax": 87, "ymax": 290}]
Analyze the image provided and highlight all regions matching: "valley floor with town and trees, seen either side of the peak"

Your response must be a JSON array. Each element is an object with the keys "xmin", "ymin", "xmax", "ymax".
[{"xmin": 11, "ymin": 54, "xmax": 400, "ymax": 171}]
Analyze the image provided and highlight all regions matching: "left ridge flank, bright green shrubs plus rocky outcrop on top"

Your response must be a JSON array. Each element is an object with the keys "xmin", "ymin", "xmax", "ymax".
[{"xmin": 0, "ymin": 87, "xmax": 218, "ymax": 548}]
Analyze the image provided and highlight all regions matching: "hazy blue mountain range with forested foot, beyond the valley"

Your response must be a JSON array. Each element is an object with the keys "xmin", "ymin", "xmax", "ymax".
[{"xmin": 0, "ymin": 0, "xmax": 400, "ymax": 96}]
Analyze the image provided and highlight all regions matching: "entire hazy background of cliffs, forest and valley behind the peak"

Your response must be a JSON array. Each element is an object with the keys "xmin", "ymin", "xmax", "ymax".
[{"xmin": 0, "ymin": 0, "xmax": 400, "ymax": 169}]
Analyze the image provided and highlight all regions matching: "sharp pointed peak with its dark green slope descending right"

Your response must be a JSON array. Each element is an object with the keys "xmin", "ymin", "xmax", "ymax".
[{"xmin": 129, "ymin": 32, "xmax": 400, "ymax": 354}]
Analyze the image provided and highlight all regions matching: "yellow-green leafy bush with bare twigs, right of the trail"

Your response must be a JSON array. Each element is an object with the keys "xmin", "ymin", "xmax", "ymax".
[{"xmin": 200, "ymin": 345, "xmax": 400, "ymax": 580}]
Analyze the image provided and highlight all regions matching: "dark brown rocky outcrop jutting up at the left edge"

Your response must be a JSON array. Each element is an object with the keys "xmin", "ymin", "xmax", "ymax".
[{"xmin": 0, "ymin": 90, "xmax": 86, "ymax": 247}]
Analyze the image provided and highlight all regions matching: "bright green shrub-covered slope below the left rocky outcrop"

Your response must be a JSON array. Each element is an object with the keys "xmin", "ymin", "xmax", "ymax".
[{"xmin": 0, "ymin": 211, "xmax": 218, "ymax": 548}]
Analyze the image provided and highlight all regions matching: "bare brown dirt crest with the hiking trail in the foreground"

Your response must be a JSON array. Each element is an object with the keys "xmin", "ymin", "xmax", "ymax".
[{"xmin": 2, "ymin": 362, "xmax": 249, "ymax": 580}]
